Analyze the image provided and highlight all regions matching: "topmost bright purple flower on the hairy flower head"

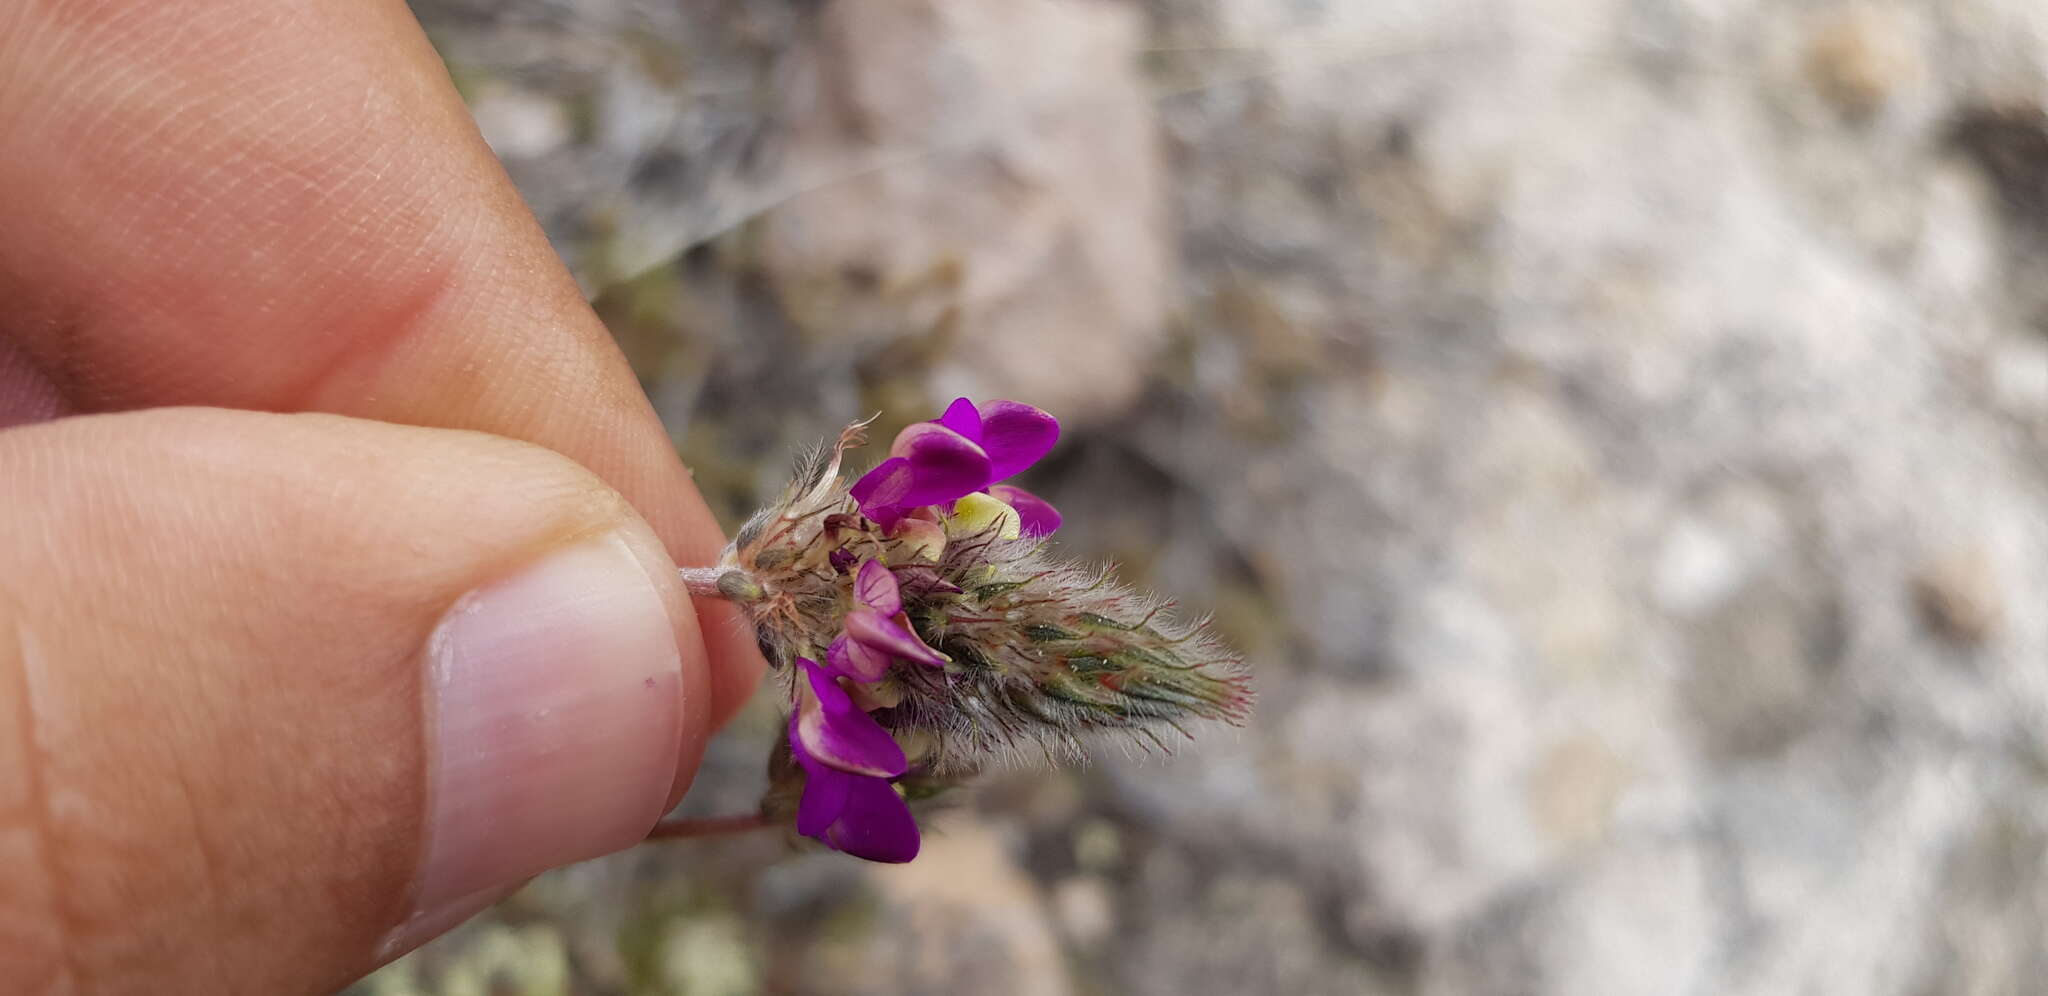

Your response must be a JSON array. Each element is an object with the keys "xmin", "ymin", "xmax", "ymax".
[{"xmin": 850, "ymin": 398, "xmax": 1059, "ymax": 529}]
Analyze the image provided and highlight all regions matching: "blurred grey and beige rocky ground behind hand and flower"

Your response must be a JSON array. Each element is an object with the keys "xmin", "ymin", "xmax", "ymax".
[{"xmin": 356, "ymin": 0, "xmax": 2048, "ymax": 996}]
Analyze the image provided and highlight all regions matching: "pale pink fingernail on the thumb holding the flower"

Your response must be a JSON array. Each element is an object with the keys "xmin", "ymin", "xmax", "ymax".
[{"xmin": 385, "ymin": 533, "xmax": 682, "ymax": 949}]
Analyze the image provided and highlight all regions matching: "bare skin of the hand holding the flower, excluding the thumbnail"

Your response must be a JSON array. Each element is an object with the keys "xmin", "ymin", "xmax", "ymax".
[{"xmin": 0, "ymin": 0, "xmax": 760, "ymax": 994}]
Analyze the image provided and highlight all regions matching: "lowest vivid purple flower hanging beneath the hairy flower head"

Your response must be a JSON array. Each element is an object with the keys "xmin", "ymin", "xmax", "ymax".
[{"xmin": 788, "ymin": 658, "xmax": 920, "ymax": 863}]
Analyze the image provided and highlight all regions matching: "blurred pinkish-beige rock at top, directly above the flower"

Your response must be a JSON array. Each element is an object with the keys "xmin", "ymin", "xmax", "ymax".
[{"xmin": 760, "ymin": 0, "xmax": 1169, "ymax": 420}]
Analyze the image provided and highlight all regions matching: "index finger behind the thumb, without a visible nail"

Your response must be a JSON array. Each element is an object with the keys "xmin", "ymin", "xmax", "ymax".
[{"xmin": 0, "ymin": 0, "xmax": 760, "ymax": 721}]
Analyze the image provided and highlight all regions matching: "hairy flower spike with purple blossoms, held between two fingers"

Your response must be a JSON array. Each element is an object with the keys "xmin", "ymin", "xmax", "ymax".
[{"xmin": 698, "ymin": 398, "xmax": 1251, "ymax": 861}]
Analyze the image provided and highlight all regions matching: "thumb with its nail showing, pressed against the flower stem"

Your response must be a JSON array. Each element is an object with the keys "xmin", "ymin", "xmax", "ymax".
[{"xmin": 0, "ymin": 410, "xmax": 709, "ymax": 992}]
